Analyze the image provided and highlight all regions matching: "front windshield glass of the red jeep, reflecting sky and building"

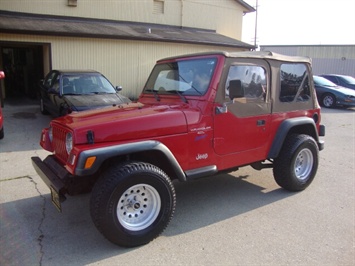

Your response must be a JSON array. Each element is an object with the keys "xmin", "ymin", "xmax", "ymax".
[{"xmin": 143, "ymin": 58, "xmax": 217, "ymax": 96}]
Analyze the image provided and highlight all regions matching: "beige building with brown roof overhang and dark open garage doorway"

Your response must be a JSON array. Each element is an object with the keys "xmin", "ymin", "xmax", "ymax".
[{"xmin": 0, "ymin": 0, "xmax": 255, "ymax": 101}]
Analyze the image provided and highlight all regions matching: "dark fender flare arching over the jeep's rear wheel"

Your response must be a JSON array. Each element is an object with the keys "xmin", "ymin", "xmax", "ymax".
[{"xmin": 268, "ymin": 117, "xmax": 320, "ymax": 159}]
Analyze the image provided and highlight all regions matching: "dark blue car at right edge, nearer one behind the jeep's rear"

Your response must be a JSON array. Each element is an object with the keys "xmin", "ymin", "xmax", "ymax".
[{"xmin": 313, "ymin": 76, "xmax": 355, "ymax": 108}]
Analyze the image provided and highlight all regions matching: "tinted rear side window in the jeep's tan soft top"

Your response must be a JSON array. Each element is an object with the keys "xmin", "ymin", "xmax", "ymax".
[{"xmin": 279, "ymin": 63, "xmax": 311, "ymax": 102}]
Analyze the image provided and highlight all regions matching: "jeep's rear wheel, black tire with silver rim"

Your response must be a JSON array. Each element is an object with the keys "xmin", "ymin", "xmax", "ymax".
[{"xmin": 273, "ymin": 134, "xmax": 319, "ymax": 191}]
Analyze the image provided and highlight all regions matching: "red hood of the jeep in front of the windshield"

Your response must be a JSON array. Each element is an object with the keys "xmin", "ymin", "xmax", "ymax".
[{"xmin": 52, "ymin": 103, "xmax": 187, "ymax": 144}]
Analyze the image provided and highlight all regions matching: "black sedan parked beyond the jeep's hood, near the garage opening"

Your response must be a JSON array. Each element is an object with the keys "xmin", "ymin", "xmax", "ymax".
[{"xmin": 39, "ymin": 70, "xmax": 131, "ymax": 117}]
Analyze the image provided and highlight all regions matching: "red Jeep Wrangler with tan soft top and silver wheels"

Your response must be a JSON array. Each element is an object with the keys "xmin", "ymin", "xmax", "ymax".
[{"xmin": 32, "ymin": 52, "xmax": 325, "ymax": 246}]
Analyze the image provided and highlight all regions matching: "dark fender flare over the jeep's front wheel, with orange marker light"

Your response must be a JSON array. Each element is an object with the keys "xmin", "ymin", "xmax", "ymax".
[{"xmin": 75, "ymin": 140, "xmax": 186, "ymax": 181}]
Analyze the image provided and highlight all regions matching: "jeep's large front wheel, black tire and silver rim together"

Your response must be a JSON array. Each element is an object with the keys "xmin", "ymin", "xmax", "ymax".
[{"xmin": 90, "ymin": 162, "xmax": 176, "ymax": 247}]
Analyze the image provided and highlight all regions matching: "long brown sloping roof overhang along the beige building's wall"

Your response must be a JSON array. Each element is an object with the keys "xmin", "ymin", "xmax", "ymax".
[{"xmin": 0, "ymin": 11, "xmax": 255, "ymax": 50}]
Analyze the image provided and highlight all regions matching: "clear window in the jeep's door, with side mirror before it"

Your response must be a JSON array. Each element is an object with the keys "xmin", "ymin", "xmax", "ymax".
[{"xmin": 225, "ymin": 65, "xmax": 267, "ymax": 103}]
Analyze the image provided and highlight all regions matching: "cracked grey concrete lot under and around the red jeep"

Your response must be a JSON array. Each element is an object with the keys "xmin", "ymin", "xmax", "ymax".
[{"xmin": 0, "ymin": 103, "xmax": 355, "ymax": 266}]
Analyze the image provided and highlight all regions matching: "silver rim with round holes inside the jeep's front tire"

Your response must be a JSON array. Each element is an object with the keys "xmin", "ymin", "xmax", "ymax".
[{"xmin": 117, "ymin": 184, "xmax": 161, "ymax": 231}]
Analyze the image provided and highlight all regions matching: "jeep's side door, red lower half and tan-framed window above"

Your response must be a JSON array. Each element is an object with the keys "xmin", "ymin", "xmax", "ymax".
[{"xmin": 214, "ymin": 58, "xmax": 271, "ymax": 165}]
